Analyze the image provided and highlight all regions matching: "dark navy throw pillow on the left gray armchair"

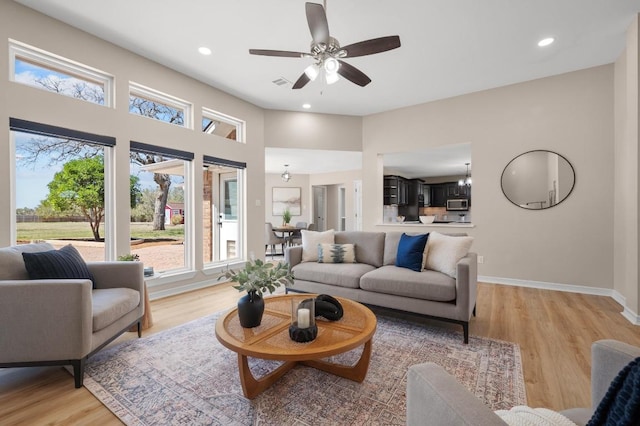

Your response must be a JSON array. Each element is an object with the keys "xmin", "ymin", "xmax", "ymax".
[{"xmin": 22, "ymin": 244, "xmax": 95, "ymax": 288}]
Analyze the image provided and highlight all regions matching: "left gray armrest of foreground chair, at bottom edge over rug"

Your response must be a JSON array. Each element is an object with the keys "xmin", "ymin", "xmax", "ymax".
[{"xmin": 407, "ymin": 362, "xmax": 506, "ymax": 426}]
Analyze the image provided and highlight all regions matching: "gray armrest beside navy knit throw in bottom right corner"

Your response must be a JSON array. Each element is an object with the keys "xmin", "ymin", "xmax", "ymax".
[{"xmin": 591, "ymin": 340, "xmax": 640, "ymax": 409}]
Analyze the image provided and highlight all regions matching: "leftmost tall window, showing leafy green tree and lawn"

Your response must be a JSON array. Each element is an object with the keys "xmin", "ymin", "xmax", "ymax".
[{"xmin": 10, "ymin": 119, "xmax": 117, "ymax": 261}]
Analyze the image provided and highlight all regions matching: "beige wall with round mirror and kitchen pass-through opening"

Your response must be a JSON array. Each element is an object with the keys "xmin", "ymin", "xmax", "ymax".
[{"xmin": 363, "ymin": 65, "xmax": 614, "ymax": 294}]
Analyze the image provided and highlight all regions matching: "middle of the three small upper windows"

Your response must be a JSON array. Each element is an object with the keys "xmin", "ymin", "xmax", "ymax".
[{"xmin": 129, "ymin": 83, "xmax": 193, "ymax": 129}]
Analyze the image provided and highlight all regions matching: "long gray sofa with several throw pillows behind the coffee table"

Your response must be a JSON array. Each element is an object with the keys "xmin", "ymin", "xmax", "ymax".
[{"xmin": 285, "ymin": 231, "xmax": 478, "ymax": 343}]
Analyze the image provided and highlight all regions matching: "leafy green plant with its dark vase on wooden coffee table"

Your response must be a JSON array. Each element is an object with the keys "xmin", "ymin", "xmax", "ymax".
[{"xmin": 220, "ymin": 259, "xmax": 293, "ymax": 328}]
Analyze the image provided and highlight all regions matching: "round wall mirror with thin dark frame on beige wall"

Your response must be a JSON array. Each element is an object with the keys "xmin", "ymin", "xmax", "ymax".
[{"xmin": 501, "ymin": 150, "xmax": 576, "ymax": 210}]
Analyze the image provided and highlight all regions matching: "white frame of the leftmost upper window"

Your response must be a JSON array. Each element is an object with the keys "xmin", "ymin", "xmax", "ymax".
[{"xmin": 9, "ymin": 39, "xmax": 115, "ymax": 108}]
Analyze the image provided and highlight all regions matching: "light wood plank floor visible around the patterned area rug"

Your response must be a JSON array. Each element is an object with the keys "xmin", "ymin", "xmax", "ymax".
[{"xmin": 0, "ymin": 284, "xmax": 640, "ymax": 425}]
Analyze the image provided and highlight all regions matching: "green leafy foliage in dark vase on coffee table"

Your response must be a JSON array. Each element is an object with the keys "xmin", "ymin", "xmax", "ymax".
[{"xmin": 220, "ymin": 259, "xmax": 293, "ymax": 297}]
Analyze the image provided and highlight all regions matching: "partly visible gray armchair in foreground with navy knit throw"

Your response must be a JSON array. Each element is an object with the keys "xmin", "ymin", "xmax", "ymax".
[{"xmin": 407, "ymin": 340, "xmax": 640, "ymax": 426}]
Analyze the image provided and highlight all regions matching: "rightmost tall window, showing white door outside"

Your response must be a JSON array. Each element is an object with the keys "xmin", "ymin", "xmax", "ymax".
[{"xmin": 202, "ymin": 156, "xmax": 246, "ymax": 265}]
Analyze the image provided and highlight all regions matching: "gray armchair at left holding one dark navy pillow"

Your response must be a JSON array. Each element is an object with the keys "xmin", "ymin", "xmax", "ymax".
[{"xmin": 0, "ymin": 243, "xmax": 144, "ymax": 388}]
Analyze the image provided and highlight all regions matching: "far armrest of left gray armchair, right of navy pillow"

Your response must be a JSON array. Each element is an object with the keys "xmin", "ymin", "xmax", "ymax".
[{"xmin": 87, "ymin": 261, "xmax": 144, "ymax": 292}]
